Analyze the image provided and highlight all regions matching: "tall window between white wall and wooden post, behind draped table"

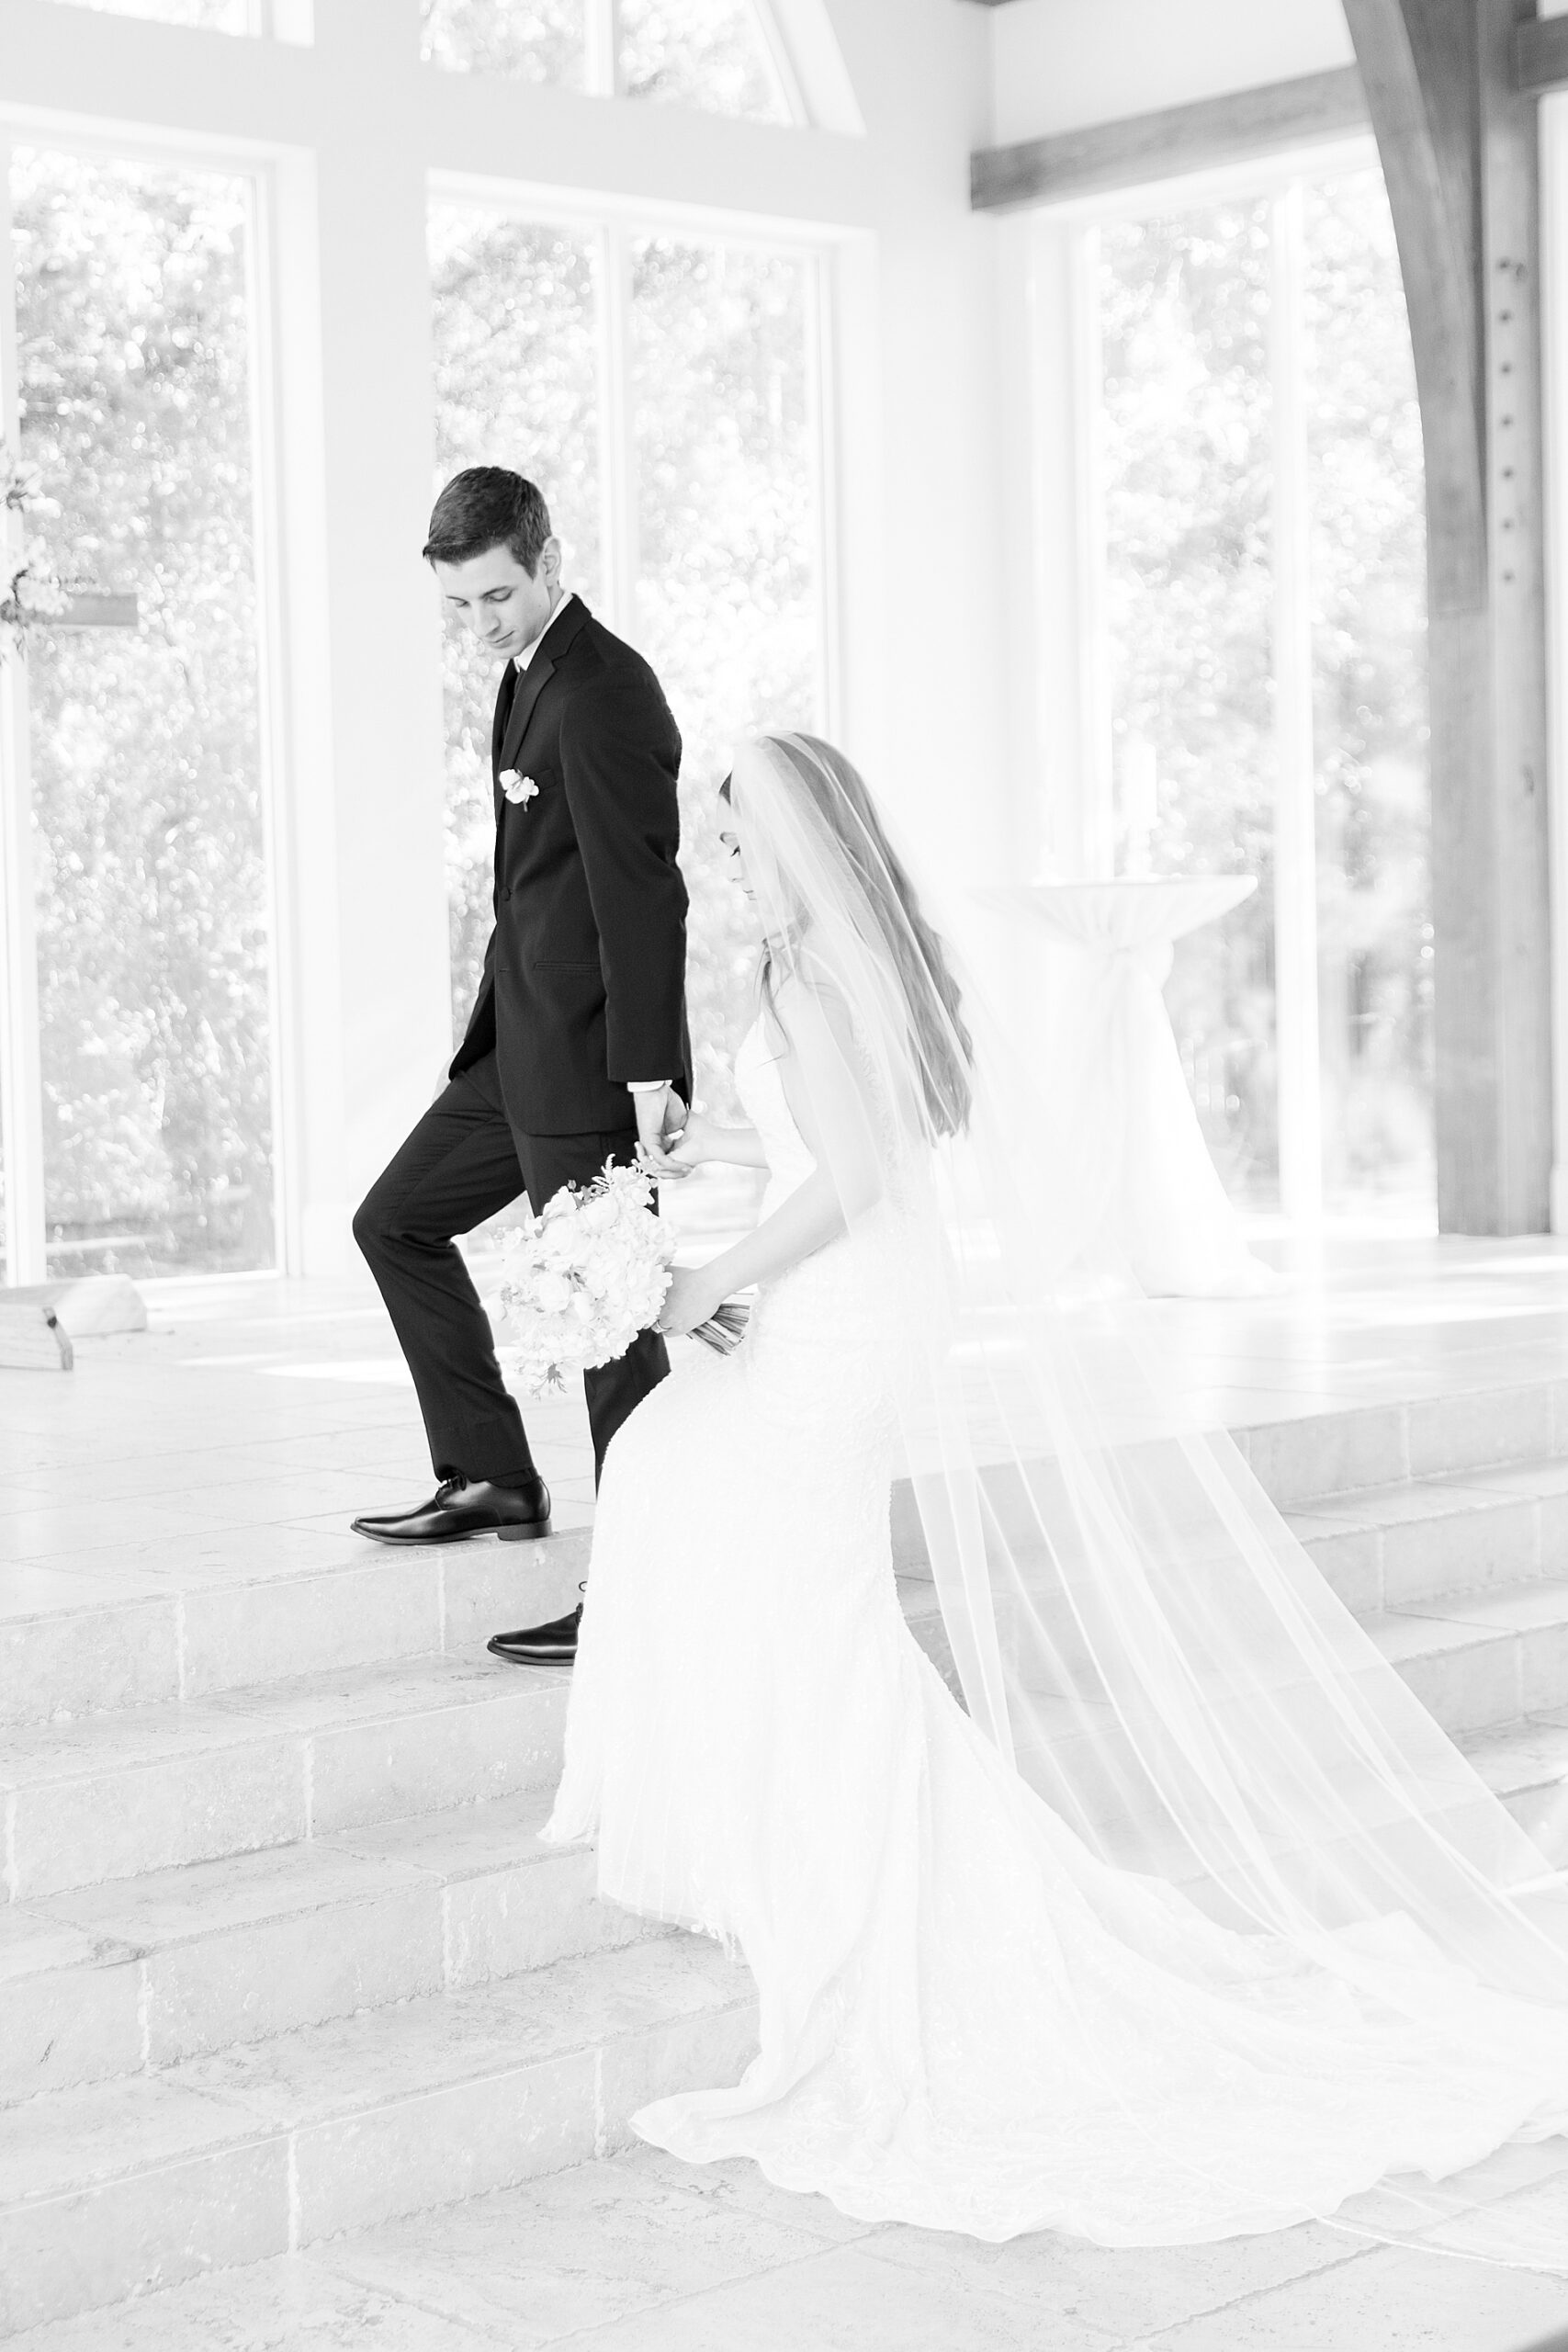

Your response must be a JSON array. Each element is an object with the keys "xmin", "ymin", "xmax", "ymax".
[{"xmin": 1089, "ymin": 169, "xmax": 1434, "ymax": 1218}]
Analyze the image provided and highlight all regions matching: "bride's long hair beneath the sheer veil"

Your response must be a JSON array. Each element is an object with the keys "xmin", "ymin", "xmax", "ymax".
[{"xmin": 719, "ymin": 734, "xmax": 974, "ymax": 1136}]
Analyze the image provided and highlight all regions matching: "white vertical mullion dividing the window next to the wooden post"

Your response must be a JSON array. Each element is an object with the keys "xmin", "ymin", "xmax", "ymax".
[{"xmin": 1269, "ymin": 181, "xmax": 1324, "ymax": 1226}]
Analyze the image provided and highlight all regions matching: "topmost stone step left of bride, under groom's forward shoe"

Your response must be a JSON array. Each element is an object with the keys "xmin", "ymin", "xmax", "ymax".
[{"xmin": 0, "ymin": 1521, "xmax": 590, "ymax": 1726}]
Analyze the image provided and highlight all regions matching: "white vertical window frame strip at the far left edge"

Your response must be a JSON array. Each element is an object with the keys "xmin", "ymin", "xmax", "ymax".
[{"xmin": 0, "ymin": 139, "xmax": 47, "ymax": 1284}]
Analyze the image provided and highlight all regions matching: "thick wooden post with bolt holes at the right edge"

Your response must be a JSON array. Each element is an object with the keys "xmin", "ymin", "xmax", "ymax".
[{"xmin": 1345, "ymin": 0, "xmax": 1551, "ymax": 1232}]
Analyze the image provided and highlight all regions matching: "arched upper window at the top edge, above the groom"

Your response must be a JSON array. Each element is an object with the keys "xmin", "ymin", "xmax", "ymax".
[{"xmin": 423, "ymin": 0, "xmax": 795, "ymax": 122}]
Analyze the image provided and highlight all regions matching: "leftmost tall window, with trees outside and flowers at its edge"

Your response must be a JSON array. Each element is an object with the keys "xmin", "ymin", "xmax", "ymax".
[{"xmin": 7, "ymin": 148, "xmax": 275, "ymax": 1272}]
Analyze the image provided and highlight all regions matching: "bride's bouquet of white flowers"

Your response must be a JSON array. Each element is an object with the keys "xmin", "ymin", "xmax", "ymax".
[{"xmin": 501, "ymin": 1159, "xmax": 745, "ymax": 1397}]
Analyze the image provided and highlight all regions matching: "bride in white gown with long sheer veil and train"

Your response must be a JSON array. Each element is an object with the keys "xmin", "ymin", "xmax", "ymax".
[{"xmin": 546, "ymin": 734, "xmax": 1568, "ymax": 2263}]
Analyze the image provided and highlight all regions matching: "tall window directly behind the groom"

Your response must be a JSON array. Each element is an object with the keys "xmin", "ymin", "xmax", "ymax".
[{"xmin": 433, "ymin": 202, "xmax": 825, "ymax": 1093}]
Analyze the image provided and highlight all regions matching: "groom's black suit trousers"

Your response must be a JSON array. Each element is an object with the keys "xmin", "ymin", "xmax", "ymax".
[{"xmin": 355, "ymin": 1054, "xmax": 670, "ymax": 1479}]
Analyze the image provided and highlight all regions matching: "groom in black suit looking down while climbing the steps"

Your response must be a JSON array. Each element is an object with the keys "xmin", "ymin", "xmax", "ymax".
[{"xmin": 353, "ymin": 466, "xmax": 691, "ymax": 1663}]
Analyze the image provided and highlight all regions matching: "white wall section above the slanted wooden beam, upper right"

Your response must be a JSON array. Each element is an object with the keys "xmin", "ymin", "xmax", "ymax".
[{"xmin": 992, "ymin": 0, "xmax": 1354, "ymax": 146}]
